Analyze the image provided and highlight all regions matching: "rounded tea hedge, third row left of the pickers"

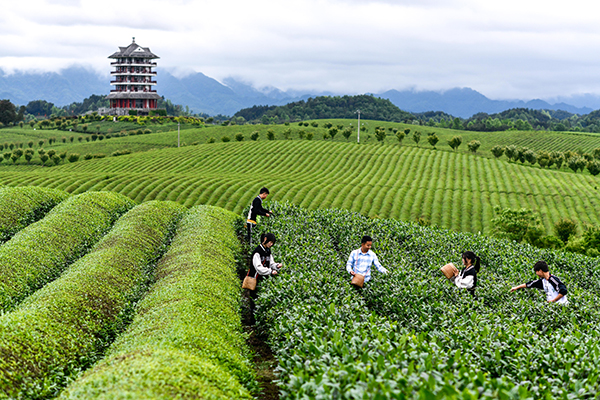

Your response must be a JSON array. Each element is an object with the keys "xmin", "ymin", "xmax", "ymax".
[{"xmin": 0, "ymin": 192, "xmax": 135, "ymax": 311}]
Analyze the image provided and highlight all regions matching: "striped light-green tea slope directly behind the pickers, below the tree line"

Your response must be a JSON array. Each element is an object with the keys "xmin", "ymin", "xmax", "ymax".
[{"xmin": 0, "ymin": 135, "xmax": 600, "ymax": 233}]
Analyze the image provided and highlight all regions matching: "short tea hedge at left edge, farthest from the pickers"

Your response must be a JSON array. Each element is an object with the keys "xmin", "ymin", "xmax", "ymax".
[{"xmin": 0, "ymin": 186, "xmax": 69, "ymax": 243}]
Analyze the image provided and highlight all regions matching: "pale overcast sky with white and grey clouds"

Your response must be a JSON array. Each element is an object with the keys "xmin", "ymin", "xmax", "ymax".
[{"xmin": 0, "ymin": 0, "xmax": 600, "ymax": 100}]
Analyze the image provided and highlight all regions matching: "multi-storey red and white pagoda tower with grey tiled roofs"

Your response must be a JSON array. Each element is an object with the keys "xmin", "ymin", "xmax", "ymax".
[{"xmin": 107, "ymin": 38, "xmax": 160, "ymax": 115}]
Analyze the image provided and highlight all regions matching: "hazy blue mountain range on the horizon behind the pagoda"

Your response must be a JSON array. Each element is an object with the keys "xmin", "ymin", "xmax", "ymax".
[{"xmin": 0, "ymin": 67, "xmax": 600, "ymax": 118}]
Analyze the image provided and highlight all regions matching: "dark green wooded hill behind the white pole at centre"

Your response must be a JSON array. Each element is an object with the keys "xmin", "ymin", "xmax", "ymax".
[{"xmin": 235, "ymin": 95, "xmax": 415, "ymax": 123}]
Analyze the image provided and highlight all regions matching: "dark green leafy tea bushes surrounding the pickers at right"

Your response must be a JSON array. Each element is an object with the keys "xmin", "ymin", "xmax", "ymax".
[{"xmin": 256, "ymin": 204, "xmax": 600, "ymax": 399}]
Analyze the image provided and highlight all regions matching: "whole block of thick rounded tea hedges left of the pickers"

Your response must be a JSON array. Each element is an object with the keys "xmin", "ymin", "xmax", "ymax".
[{"xmin": 0, "ymin": 187, "xmax": 257, "ymax": 399}]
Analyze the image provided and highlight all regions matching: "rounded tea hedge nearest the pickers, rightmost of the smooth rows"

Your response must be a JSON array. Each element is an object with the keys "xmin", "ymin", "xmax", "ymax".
[{"xmin": 61, "ymin": 206, "xmax": 256, "ymax": 399}]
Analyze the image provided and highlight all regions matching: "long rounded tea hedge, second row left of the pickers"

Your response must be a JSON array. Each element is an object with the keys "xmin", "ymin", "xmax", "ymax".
[{"xmin": 0, "ymin": 201, "xmax": 185, "ymax": 398}]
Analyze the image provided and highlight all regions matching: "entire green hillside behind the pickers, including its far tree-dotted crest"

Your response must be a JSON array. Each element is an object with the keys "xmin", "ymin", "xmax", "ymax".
[{"xmin": 0, "ymin": 120, "xmax": 600, "ymax": 238}]
